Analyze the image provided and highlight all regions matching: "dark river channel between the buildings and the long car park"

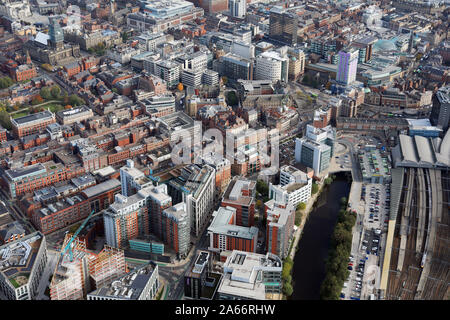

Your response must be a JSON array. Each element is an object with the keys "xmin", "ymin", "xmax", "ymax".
[{"xmin": 290, "ymin": 173, "xmax": 351, "ymax": 300}]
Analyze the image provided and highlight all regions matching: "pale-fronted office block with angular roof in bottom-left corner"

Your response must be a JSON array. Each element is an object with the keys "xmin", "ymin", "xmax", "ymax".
[{"xmin": 0, "ymin": 231, "xmax": 47, "ymax": 300}]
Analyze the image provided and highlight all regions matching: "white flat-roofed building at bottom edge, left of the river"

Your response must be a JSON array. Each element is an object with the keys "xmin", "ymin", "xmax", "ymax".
[{"xmin": 217, "ymin": 250, "xmax": 283, "ymax": 300}]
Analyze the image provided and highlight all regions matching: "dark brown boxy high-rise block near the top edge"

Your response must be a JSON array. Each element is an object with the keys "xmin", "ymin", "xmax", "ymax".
[{"xmin": 269, "ymin": 6, "xmax": 298, "ymax": 45}]
